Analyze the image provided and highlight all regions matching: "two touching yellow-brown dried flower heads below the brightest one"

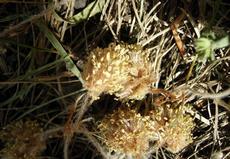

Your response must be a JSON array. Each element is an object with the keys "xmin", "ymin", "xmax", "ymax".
[{"xmin": 98, "ymin": 100, "xmax": 194, "ymax": 158}]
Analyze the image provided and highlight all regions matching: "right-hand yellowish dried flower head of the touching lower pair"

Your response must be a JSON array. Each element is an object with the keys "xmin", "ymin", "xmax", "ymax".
[{"xmin": 150, "ymin": 96, "xmax": 195, "ymax": 153}]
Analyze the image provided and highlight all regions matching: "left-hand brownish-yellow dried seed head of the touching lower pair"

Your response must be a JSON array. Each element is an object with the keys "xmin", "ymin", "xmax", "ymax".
[{"xmin": 98, "ymin": 107, "xmax": 157, "ymax": 158}]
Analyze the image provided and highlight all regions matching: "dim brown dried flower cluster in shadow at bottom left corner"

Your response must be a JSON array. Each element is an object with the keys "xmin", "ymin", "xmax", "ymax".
[{"xmin": 0, "ymin": 121, "xmax": 46, "ymax": 159}]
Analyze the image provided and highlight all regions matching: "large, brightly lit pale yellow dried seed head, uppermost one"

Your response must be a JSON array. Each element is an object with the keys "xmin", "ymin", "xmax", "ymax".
[{"xmin": 83, "ymin": 43, "xmax": 155, "ymax": 100}]
